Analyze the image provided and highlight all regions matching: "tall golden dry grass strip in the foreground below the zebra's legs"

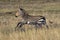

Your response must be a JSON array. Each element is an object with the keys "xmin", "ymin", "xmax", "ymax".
[{"xmin": 0, "ymin": 28, "xmax": 60, "ymax": 40}]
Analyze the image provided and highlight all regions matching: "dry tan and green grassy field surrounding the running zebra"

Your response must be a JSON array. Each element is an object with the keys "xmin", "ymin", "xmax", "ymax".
[{"xmin": 0, "ymin": 1, "xmax": 60, "ymax": 40}]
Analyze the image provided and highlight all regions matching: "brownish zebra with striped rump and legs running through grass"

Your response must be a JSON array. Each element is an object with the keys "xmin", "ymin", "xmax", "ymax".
[{"xmin": 16, "ymin": 8, "xmax": 48, "ymax": 28}]
